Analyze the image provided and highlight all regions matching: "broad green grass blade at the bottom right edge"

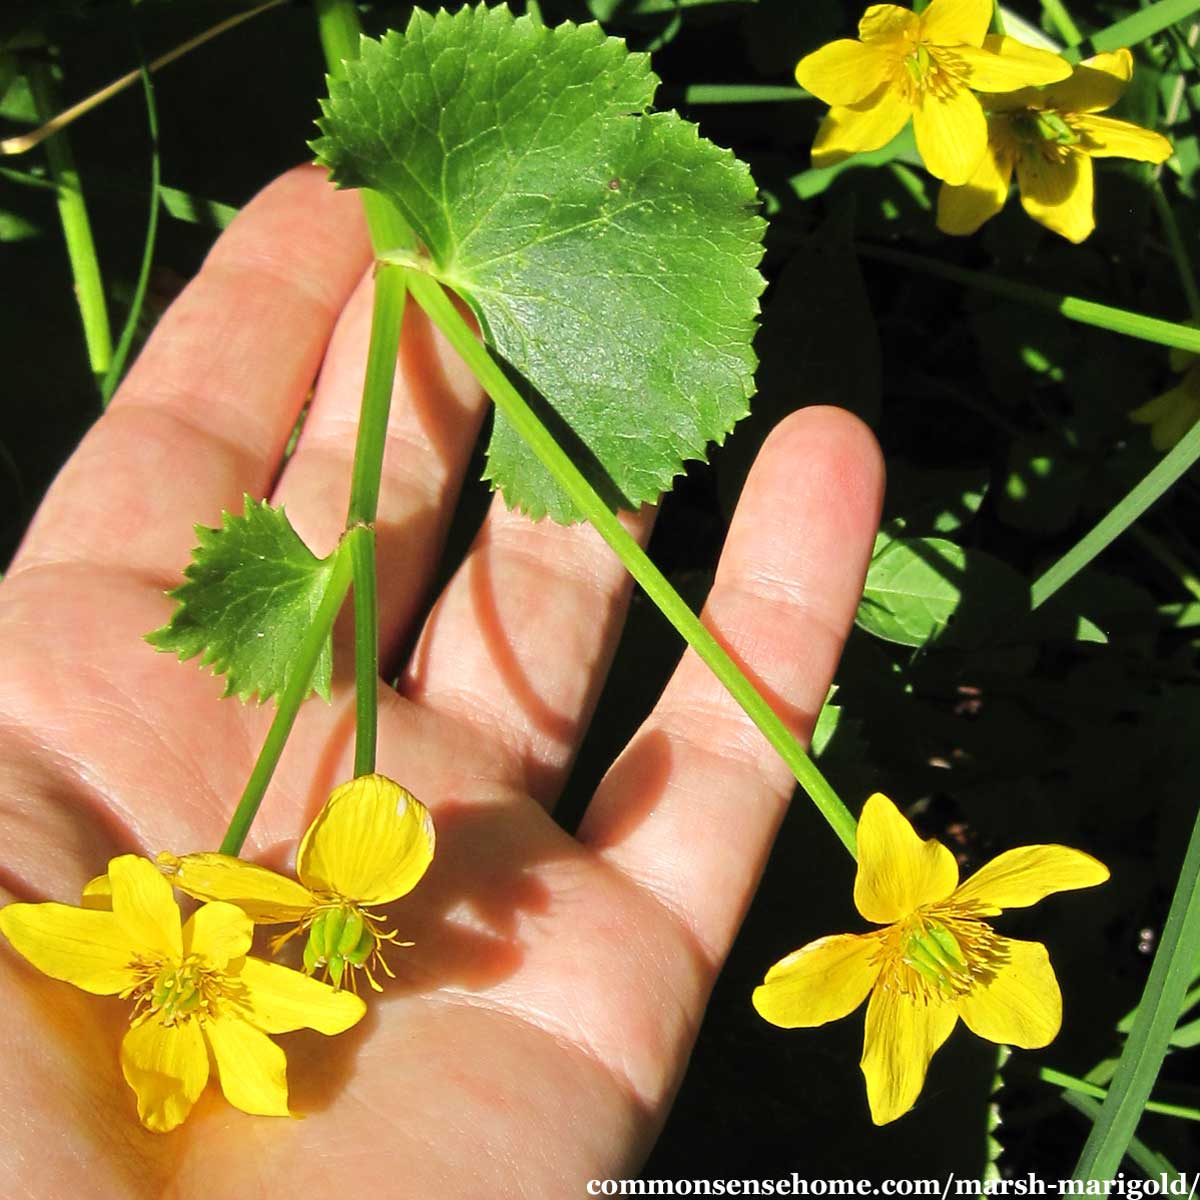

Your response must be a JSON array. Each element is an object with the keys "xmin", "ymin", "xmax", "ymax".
[{"xmin": 1075, "ymin": 796, "xmax": 1200, "ymax": 1180}]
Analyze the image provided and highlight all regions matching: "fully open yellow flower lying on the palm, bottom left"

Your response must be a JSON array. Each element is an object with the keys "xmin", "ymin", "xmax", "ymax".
[{"xmin": 0, "ymin": 854, "xmax": 366, "ymax": 1133}]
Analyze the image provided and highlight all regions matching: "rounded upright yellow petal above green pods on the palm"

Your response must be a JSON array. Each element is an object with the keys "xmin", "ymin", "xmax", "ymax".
[{"xmin": 296, "ymin": 775, "xmax": 433, "ymax": 905}]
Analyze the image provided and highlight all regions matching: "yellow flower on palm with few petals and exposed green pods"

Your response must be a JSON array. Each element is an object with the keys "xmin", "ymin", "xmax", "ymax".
[{"xmin": 158, "ymin": 775, "xmax": 433, "ymax": 991}]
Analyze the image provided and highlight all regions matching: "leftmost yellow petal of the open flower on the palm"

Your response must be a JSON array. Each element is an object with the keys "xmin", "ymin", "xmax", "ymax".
[{"xmin": 0, "ymin": 904, "xmax": 140, "ymax": 996}]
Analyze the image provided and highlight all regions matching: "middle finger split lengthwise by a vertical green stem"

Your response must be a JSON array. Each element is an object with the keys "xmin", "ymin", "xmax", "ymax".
[{"xmin": 274, "ymin": 272, "xmax": 486, "ymax": 661}]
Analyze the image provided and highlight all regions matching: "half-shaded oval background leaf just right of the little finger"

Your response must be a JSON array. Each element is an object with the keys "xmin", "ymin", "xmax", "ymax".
[{"xmin": 856, "ymin": 534, "xmax": 1030, "ymax": 646}]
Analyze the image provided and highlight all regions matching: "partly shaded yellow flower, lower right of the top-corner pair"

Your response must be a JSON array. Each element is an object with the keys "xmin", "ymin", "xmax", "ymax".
[{"xmin": 937, "ymin": 46, "xmax": 1172, "ymax": 242}]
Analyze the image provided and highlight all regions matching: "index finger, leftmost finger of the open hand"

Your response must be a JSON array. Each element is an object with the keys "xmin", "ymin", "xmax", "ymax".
[{"xmin": 13, "ymin": 167, "xmax": 368, "ymax": 578}]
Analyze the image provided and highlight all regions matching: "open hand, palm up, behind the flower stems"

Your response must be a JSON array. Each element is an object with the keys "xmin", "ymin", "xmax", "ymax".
[{"xmin": 0, "ymin": 168, "xmax": 882, "ymax": 1200}]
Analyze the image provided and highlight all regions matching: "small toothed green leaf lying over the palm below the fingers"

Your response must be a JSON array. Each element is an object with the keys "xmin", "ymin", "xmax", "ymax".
[{"xmin": 146, "ymin": 496, "xmax": 337, "ymax": 703}]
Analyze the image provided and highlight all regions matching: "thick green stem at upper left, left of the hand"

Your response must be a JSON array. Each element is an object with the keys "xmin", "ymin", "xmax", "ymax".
[{"xmin": 26, "ymin": 62, "xmax": 113, "ymax": 386}]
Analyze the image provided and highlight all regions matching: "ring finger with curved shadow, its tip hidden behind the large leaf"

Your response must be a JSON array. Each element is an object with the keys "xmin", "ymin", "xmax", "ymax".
[{"xmin": 400, "ymin": 497, "xmax": 653, "ymax": 804}]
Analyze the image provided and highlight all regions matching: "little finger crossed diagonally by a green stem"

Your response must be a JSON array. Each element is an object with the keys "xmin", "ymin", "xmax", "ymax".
[{"xmin": 580, "ymin": 408, "xmax": 883, "ymax": 962}]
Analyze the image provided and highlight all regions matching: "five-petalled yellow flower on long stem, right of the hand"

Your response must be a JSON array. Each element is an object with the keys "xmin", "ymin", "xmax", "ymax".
[{"xmin": 754, "ymin": 793, "xmax": 1109, "ymax": 1124}]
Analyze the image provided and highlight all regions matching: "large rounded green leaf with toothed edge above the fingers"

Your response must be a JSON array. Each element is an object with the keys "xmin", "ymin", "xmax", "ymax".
[{"xmin": 313, "ymin": 7, "xmax": 764, "ymax": 521}]
